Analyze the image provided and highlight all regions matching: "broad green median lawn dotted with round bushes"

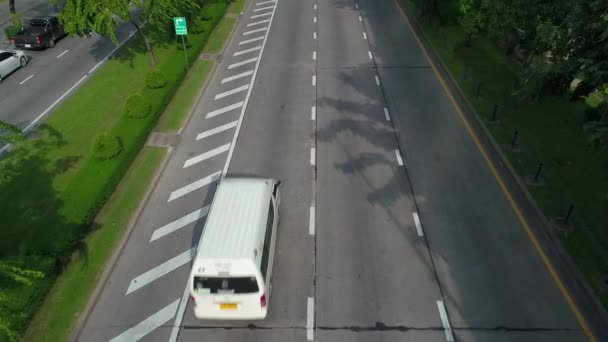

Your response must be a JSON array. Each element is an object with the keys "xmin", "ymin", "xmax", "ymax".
[{"xmin": 0, "ymin": 2, "xmax": 226, "ymax": 341}]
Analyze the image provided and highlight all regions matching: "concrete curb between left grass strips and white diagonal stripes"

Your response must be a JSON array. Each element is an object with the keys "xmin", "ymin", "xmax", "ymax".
[{"xmin": 69, "ymin": 3, "xmax": 247, "ymax": 342}]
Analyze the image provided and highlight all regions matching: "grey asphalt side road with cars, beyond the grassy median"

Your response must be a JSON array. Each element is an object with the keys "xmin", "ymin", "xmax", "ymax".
[{"xmin": 0, "ymin": 1, "xmax": 135, "ymax": 133}]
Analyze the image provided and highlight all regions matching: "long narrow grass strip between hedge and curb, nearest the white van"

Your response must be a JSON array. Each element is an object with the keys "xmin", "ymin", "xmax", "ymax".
[{"xmin": 23, "ymin": 147, "xmax": 166, "ymax": 342}]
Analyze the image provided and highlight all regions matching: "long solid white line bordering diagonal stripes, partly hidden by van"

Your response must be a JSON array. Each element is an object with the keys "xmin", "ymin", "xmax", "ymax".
[{"xmin": 169, "ymin": 2, "xmax": 276, "ymax": 342}]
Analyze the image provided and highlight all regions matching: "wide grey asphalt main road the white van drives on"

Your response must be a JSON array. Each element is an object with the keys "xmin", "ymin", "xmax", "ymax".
[{"xmin": 73, "ymin": 0, "xmax": 600, "ymax": 342}]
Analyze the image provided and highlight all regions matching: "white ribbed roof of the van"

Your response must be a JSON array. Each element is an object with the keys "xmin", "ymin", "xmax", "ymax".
[{"xmin": 197, "ymin": 177, "xmax": 274, "ymax": 262}]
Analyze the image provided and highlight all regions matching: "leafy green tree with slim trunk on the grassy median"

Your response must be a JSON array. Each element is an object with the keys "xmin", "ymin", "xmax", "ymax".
[{"xmin": 51, "ymin": 0, "xmax": 198, "ymax": 66}]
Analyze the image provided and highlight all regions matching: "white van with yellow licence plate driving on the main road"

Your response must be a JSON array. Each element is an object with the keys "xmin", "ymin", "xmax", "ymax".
[{"xmin": 189, "ymin": 177, "xmax": 281, "ymax": 319}]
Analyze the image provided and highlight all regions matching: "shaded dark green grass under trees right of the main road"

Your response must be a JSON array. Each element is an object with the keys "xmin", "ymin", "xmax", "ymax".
[{"xmin": 403, "ymin": 0, "xmax": 608, "ymax": 306}]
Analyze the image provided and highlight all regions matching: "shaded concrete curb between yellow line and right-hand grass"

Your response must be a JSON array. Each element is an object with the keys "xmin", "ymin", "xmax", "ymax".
[{"xmin": 398, "ymin": 0, "xmax": 608, "ymax": 341}]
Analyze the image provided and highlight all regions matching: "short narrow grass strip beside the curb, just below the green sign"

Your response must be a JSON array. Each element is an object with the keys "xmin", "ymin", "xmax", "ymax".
[{"xmin": 156, "ymin": 60, "xmax": 214, "ymax": 133}]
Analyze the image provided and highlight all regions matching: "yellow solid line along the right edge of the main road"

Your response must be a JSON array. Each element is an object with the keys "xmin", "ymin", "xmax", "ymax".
[{"xmin": 394, "ymin": 0, "xmax": 597, "ymax": 342}]
